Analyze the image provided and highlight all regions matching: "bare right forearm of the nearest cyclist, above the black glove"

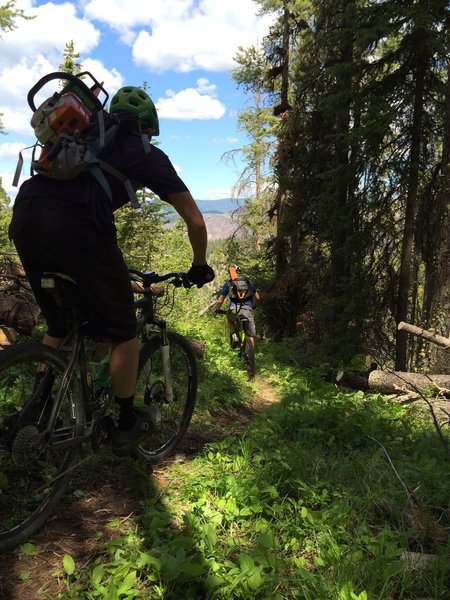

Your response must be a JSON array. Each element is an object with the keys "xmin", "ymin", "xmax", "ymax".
[{"xmin": 168, "ymin": 191, "xmax": 208, "ymax": 265}]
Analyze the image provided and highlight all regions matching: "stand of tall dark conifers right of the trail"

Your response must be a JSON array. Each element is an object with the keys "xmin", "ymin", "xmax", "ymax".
[{"xmin": 232, "ymin": 0, "xmax": 449, "ymax": 364}]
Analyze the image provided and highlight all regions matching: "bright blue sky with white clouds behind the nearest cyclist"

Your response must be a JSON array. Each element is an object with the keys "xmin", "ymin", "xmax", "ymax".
[{"xmin": 0, "ymin": 0, "xmax": 271, "ymax": 200}]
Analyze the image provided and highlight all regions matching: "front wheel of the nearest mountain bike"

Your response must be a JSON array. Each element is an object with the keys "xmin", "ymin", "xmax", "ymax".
[{"xmin": 135, "ymin": 332, "xmax": 197, "ymax": 463}]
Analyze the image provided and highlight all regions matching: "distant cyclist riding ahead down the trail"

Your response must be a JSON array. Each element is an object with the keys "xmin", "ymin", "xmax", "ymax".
[{"xmin": 214, "ymin": 265, "xmax": 259, "ymax": 348}]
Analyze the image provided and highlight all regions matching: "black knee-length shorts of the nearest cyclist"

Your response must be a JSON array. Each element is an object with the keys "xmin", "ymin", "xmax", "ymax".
[{"xmin": 9, "ymin": 198, "xmax": 136, "ymax": 343}]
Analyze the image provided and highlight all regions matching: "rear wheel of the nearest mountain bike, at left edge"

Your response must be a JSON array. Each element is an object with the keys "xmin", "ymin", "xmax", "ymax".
[{"xmin": 0, "ymin": 343, "xmax": 84, "ymax": 550}]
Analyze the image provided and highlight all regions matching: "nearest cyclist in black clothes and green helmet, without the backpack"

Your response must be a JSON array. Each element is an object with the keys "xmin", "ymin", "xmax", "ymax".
[{"xmin": 9, "ymin": 86, "xmax": 214, "ymax": 456}]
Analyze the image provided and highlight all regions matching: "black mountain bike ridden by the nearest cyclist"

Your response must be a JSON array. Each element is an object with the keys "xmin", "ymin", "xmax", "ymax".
[{"xmin": 0, "ymin": 269, "xmax": 197, "ymax": 550}]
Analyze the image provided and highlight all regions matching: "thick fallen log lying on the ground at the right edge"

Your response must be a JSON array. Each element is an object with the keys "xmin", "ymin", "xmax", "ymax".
[{"xmin": 336, "ymin": 370, "xmax": 450, "ymax": 398}]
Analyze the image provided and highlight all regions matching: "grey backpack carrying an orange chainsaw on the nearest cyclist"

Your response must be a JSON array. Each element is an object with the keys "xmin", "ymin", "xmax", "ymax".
[{"xmin": 13, "ymin": 71, "xmax": 144, "ymax": 208}]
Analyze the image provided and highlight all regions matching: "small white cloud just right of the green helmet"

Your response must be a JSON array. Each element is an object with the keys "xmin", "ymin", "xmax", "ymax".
[{"xmin": 156, "ymin": 79, "xmax": 225, "ymax": 121}]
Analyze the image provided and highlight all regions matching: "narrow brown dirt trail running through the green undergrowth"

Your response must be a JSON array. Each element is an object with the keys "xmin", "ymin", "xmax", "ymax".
[{"xmin": 0, "ymin": 378, "xmax": 277, "ymax": 600}]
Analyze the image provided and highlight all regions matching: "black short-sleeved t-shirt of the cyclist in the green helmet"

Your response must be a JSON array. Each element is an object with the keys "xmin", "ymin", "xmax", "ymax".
[{"xmin": 14, "ymin": 131, "xmax": 188, "ymax": 230}]
